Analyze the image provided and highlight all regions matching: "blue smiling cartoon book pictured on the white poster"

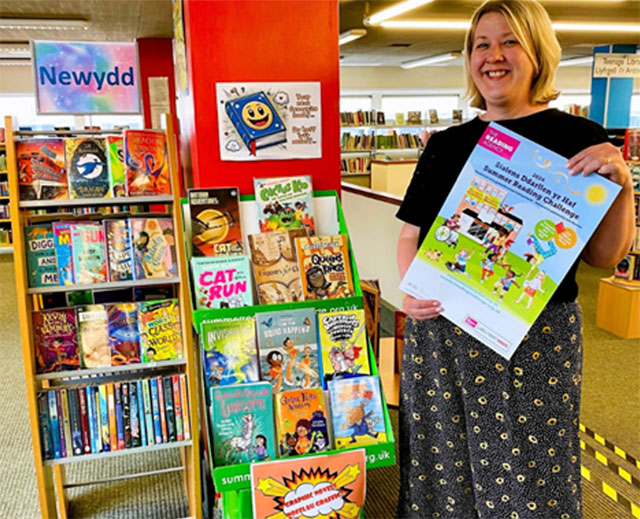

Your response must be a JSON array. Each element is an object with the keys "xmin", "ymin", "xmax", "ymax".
[{"xmin": 224, "ymin": 91, "xmax": 287, "ymax": 155}]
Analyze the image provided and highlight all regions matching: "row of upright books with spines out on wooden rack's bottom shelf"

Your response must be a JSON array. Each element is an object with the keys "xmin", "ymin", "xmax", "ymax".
[{"xmin": 37, "ymin": 374, "xmax": 191, "ymax": 460}]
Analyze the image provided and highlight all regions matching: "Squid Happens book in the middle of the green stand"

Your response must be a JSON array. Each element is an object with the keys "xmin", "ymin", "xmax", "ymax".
[{"xmin": 256, "ymin": 308, "xmax": 320, "ymax": 393}]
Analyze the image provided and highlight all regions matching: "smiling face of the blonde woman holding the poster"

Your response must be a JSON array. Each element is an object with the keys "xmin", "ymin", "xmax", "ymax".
[{"xmin": 470, "ymin": 13, "xmax": 534, "ymax": 119}]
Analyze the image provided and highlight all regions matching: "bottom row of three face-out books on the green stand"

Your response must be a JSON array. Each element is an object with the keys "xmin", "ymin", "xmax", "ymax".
[{"xmin": 210, "ymin": 376, "xmax": 388, "ymax": 466}]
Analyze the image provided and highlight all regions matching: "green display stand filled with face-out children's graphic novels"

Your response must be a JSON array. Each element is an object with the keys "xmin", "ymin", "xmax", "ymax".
[{"xmin": 184, "ymin": 176, "xmax": 395, "ymax": 519}]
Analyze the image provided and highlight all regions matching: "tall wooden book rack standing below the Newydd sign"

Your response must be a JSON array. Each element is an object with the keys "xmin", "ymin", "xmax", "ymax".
[{"xmin": 0, "ymin": 117, "xmax": 202, "ymax": 517}]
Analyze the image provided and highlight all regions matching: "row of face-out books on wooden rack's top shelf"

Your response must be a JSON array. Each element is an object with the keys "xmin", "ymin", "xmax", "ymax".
[{"xmin": 16, "ymin": 130, "xmax": 171, "ymax": 200}]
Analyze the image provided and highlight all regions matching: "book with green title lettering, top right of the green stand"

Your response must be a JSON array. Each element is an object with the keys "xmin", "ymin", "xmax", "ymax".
[{"xmin": 253, "ymin": 176, "xmax": 316, "ymax": 236}]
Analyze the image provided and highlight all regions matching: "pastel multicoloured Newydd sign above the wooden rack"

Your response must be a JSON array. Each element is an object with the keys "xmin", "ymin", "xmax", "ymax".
[{"xmin": 33, "ymin": 41, "xmax": 140, "ymax": 114}]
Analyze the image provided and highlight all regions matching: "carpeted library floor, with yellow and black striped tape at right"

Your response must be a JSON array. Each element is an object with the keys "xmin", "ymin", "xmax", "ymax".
[{"xmin": 0, "ymin": 255, "xmax": 640, "ymax": 519}]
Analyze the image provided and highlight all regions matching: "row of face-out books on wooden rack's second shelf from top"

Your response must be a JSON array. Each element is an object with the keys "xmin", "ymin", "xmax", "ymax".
[{"xmin": 25, "ymin": 217, "xmax": 177, "ymax": 288}]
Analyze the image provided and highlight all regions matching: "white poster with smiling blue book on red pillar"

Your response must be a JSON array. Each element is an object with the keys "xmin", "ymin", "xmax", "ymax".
[{"xmin": 216, "ymin": 82, "xmax": 322, "ymax": 161}]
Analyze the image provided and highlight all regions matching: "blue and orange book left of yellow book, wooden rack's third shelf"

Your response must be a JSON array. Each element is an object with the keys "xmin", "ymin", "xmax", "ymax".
[{"xmin": 107, "ymin": 303, "xmax": 140, "ymax": 366}]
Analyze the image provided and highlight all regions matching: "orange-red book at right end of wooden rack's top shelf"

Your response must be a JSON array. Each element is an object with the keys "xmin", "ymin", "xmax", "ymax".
[{"xmin": 124, "ymin": 130, "xmax": 171, "ymax": 196}]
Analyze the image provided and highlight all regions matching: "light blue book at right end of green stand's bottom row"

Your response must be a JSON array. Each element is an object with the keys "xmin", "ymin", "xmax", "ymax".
[{"xmin": 329, "ymin": 376, "xmax": 387, "ymax": 449}]
